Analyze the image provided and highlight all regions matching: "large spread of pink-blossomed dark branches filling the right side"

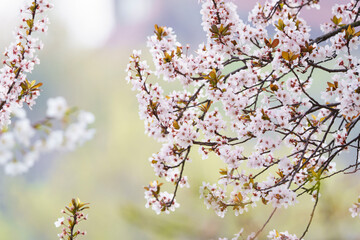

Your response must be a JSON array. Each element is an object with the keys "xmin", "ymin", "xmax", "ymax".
[{"xmin": 127, "ymin": 0, "xmax": 360, "ymax": 239}]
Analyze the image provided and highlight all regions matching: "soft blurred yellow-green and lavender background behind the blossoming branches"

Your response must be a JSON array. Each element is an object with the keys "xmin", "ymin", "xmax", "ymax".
[{"xmin": 0, "ymin": 0, "xmax": 360, "ymax": 240}]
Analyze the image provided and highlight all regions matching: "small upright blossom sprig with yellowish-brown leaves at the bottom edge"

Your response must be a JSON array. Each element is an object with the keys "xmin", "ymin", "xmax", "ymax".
[{"xmin": 54, "ymin": 198, "xmax": 89, "ymax": 240}]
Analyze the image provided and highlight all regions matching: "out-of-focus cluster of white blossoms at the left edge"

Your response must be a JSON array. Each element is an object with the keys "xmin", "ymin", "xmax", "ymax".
[{"xmin": 0, "ymin": 97, "xmax": 95, "ymax": 175}]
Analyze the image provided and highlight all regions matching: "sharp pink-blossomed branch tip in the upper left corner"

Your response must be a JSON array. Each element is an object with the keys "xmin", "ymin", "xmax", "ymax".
[{"xmin": 0, "ymin": 0, "xmax": 53, "ymax": 127}]
